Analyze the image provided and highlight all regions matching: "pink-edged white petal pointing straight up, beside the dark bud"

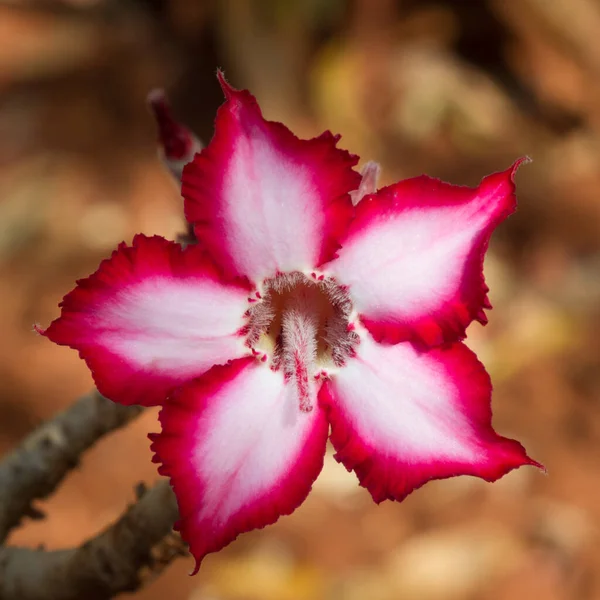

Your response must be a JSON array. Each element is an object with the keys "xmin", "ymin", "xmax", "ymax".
[{"xmin": 182, "ymin": 73, "xmax": 361, "ymax": 282}]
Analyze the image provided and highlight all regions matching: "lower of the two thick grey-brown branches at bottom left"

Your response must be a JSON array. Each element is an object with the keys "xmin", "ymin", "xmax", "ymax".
[{"xmin": 0, "ymin": 481, "xmax": 186, "ymax": 600}]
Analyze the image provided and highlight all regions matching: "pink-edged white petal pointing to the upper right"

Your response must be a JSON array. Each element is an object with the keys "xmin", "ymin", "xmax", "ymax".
[{"xmin": 324, "ymin": 159, "xmax": 523, "ymax": 346}]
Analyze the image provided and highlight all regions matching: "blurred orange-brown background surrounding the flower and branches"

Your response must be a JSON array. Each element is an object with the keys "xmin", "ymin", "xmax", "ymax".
[{"xmin": 0, "ymin": 0, "xmax": 600, "ymax": 600}]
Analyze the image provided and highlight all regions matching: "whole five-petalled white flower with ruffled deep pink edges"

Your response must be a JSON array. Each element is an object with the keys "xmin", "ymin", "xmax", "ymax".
[{"xmin": 42, "ymin": 74, "xmax": 538, "ymax": 570}]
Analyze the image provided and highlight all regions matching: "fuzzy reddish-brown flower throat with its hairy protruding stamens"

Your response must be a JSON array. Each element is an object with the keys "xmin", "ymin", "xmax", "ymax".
[{"xmin": 246, "ymin": 272, "xmax": 358, "ymax": 411}]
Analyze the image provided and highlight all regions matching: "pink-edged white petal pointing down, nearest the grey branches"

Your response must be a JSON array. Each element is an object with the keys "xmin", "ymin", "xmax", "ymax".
[{"xmin": 152, "ymin": 358, "xmax": 328, "ymax": 572}]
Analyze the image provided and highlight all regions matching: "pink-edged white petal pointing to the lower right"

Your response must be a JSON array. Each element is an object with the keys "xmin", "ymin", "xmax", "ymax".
[{"xmin": 320, "ymin": 335, "xmax": 539, "ymax": 502}]
